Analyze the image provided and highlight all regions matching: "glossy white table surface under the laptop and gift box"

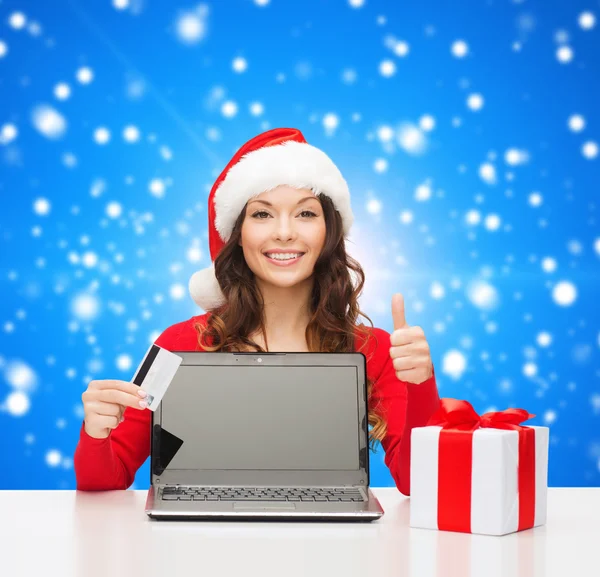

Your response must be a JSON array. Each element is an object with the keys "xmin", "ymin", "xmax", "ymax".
[{"xmin": 0, "ymin": 488, "xmax": 600, "ymax": 577}]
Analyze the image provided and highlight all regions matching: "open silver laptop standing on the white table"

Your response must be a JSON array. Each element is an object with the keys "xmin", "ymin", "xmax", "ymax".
[{"xmin": 146, "ymin": 351, "xmax": 383, "ymax": 521}]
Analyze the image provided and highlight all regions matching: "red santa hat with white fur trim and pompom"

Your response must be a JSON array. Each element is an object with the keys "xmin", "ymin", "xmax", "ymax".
[{"xmin": 189, "ymin": 128, "xmax": 354, "ymax": 311}]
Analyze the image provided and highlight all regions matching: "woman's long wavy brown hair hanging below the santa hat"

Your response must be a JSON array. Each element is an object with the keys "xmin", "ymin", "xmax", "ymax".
[{"xmin": 195, "ymin": 194, "xmax": 387, "ymax": 450}]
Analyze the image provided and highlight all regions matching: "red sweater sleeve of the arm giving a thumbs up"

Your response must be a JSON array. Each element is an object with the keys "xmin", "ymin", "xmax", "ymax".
[{"xmin": 372, "ymin": 331, "xmax": 440, "ymax": 496}]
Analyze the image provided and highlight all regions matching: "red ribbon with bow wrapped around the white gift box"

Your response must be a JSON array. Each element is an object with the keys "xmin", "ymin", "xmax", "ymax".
[{"xmin": 427, "ymin": 399, "xmax": 535, "ymax": 533}]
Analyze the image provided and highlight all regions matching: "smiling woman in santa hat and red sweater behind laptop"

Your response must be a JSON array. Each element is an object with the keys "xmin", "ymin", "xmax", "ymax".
[{"xmin": 74, "ymin": 128, "xmax": 440, "ymax": 495}]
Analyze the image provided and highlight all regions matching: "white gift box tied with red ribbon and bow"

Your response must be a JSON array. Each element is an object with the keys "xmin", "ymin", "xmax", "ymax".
[{"xmin": 410, "ymin": 399, "xmax": 549, "ymax": 535}]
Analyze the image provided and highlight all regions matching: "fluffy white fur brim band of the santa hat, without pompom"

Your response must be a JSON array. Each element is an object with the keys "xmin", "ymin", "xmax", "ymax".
[{"xmin": 215, "ymin": 140, "xmax": 354, "ymax": 242}]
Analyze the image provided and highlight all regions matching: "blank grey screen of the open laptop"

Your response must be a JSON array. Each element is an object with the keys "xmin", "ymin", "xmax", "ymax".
[{"xmin": 161, "ymin": 365, "xmax": 360, "ymax": 471}]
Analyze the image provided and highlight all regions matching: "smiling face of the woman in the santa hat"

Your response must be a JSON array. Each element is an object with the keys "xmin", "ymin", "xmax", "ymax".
[{"xmin": 239, "ymin": 186, "xmax": 325, "ymax": 287}]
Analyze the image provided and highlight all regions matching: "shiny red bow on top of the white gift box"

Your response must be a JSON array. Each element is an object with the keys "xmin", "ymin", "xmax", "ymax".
[{"xmin": 427, "ymin": 399, "xmax": 535, "ymax": 431}]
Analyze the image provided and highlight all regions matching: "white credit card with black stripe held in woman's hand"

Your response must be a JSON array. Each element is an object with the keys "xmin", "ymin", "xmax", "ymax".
[{"xmin": 132, "ymin": 344, "xmax": 183, "ymax": 411}]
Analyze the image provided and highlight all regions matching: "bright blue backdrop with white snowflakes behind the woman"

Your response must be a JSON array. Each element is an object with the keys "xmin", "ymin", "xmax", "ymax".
[{"xmin": 0, "ymin": 0, "xmax": 600, "ymax": 489}]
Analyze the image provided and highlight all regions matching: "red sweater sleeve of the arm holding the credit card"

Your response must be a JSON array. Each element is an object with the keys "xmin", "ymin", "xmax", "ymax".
[{"xmin": 73, "ymin": 324, "xmax": 181, "ymax": 491}]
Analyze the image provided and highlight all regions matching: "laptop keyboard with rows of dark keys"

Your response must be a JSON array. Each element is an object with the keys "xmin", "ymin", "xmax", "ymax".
[{"xmin": 162, "ymin": 486, "xmax": 364, "ymax": 502}]
